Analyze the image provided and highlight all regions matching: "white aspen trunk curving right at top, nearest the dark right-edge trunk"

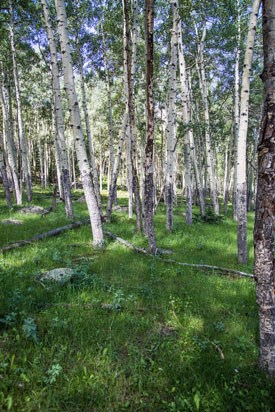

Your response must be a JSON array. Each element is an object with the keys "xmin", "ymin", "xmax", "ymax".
[{"xmin": 236, "ymin": 0, "xmax": 261, "ymax": 263}]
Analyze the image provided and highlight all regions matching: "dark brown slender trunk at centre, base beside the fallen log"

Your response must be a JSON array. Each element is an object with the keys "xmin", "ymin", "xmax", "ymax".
[{"xmin": 144, "ymin": 0, "xmax": 156, "ymax": 254}]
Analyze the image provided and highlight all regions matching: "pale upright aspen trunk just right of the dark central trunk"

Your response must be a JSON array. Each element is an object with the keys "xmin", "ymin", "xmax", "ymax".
[{"xmin": 165, "ymin": 2, "xmax": 178, "ymax": 231}]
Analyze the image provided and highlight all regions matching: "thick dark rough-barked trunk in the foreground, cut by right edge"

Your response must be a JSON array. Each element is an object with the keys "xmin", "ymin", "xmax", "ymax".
[{"xmin": 254, "ymin": 0, "xmax": 275, "ymax": 377}]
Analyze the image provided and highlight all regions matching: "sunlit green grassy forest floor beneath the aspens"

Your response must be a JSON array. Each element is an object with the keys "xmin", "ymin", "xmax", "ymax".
[{"xmin": 0, "ymin": 188, "xmax": 275, "ymax": 412}]
